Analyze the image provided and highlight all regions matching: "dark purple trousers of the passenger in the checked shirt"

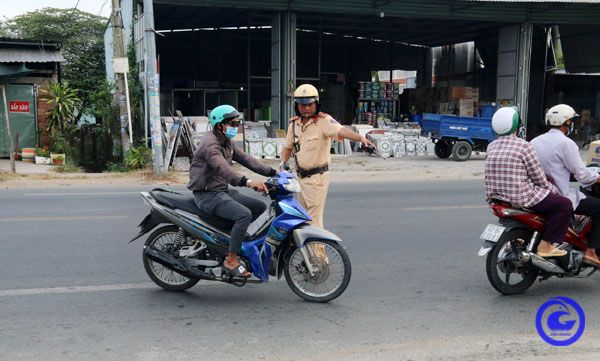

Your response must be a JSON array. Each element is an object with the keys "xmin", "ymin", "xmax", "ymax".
[{"xmin": 529, "ymin": 193, "xmax": 573, "ymax": 243}]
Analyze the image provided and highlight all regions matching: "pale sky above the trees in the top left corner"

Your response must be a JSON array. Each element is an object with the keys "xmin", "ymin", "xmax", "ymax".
[{"xmin": 0, "ymin": 0, "xmax": 112, "ymax": 19}]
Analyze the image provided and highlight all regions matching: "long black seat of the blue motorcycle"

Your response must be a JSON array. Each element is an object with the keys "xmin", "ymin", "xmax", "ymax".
[{"xmin": 150, "ymin": 188, "xmax": 234, "ymax": 234}]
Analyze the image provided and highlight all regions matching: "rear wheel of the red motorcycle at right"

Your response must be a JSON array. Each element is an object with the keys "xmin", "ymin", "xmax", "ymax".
[{"xmin": 485, "ymin": 229, "xmax": 538, "ymax": 295}]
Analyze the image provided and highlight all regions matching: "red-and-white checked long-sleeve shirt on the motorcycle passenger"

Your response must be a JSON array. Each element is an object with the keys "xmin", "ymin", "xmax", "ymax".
[{"xmin": 485, "ymin": 135, "xmax": 556, "ymax": 207}]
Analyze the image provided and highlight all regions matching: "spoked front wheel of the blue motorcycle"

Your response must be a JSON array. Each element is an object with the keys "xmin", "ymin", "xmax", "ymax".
[{"xmin": 284, "ymin": 239, "xmax": 352, "ymax": 302}]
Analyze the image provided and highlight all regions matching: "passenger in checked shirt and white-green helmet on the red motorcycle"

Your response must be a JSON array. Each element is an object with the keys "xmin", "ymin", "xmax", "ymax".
[{"xmin": 485, "ymin": 107, "xmax": 573, "ymax": 257}]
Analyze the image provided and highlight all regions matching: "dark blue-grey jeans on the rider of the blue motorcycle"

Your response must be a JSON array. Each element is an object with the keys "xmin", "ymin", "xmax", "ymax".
[{"xmin": 194, "ymin": 189, "xmax": 267, "ymax": 253}]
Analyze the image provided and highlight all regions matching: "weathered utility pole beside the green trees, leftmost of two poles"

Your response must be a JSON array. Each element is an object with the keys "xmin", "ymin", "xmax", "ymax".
[{"xmin": 112, "ymin": 0, "xmax": 131, "ymax": 154}]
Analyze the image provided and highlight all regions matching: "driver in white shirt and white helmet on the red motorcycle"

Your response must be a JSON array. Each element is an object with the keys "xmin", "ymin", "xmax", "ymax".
[{"xmin": 531, "ymin": 104, "xmax": 600, "ymax": 267}]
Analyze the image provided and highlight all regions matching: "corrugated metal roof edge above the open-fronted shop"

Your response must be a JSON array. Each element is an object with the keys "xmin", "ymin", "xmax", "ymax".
[{"xmin": 154, "ymin": 0, "xmax": 600, "ymax": 24}]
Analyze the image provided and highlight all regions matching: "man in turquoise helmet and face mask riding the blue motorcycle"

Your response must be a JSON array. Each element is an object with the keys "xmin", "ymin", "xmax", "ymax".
[{"xmin": 187, "ymin": 105, "xmax": 277, "ymax": 277}]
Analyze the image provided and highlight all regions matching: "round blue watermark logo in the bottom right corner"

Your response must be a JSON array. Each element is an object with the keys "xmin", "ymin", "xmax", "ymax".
[{"xmin": 535, "ymin": 297, "xmax": 585, "ymax": 346}]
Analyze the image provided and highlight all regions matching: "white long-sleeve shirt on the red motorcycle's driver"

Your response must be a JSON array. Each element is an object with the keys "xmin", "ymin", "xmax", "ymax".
[{"xmin": 531, "ymin": 128, "xmax": 598, "ymax": 209}]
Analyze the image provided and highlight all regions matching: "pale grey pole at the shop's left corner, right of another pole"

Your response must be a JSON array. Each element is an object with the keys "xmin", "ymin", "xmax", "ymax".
[{"xmin": 144, "ymin": 0, "xmax": 168, "ymax": 175}]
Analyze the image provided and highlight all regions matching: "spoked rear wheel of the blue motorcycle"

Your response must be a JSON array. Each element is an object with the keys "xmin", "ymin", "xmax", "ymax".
[{"xmin": 143, "ymin": 225, "xmax": 199, "ymax": 292}]
